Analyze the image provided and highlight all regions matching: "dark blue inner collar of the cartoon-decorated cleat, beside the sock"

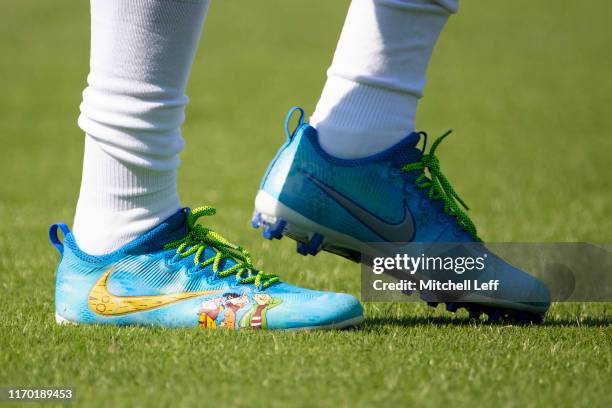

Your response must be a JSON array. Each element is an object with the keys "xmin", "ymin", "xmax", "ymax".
[{"xmin": 128, "ymin": 208, "xmax": 189, "ymax": 253}]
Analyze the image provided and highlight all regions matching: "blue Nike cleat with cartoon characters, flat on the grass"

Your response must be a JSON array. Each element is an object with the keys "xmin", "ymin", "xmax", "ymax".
[{"xmin": 49, "ymin": 207, "xmax": 363, "ymax": 330}]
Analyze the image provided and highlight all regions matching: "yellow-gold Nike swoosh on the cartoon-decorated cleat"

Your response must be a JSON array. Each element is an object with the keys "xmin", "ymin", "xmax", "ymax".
[{"xmin": 87, "ymin": 267, "xmax": 223, "ymax": 316}]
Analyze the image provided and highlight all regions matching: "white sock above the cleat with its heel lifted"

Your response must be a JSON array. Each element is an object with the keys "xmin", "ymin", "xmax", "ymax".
[{"xmin": 310, "ymin": 0, "xmax": 458, "ymax": 159}]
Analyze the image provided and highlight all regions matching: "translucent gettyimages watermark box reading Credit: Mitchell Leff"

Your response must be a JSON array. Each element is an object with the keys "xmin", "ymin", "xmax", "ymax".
[{"xmin": 361, "ymin": 243, "xmax": 612, "ymax": 302}]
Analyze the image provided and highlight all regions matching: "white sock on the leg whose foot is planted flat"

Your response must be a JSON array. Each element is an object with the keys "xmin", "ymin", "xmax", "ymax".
[{"xmin": 73, "ymin": 0, "xmax": 208, "ymax": 255}]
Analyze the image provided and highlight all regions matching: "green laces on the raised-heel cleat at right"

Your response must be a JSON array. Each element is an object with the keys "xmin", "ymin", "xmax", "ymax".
[{"xmin": 402, "ymin": 130, "xmax": 481, "ymax": 241}]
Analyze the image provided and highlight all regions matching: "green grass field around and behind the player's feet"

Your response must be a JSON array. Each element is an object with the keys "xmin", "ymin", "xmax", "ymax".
[{"xmin": 0, "ymin": 0, "xmax": 612, "ymax": 407}]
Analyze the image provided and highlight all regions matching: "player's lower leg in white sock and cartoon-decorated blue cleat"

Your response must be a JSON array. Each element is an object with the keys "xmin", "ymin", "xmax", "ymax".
[{"xmin": 49, "ymin": 0, "xmax": 363, "ymax": 329}]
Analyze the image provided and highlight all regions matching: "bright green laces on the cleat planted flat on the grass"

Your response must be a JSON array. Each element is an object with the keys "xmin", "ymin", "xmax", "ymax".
[{"xmin": 164, "ymin": 206, "xmax": 280, "ymax": 289}]
